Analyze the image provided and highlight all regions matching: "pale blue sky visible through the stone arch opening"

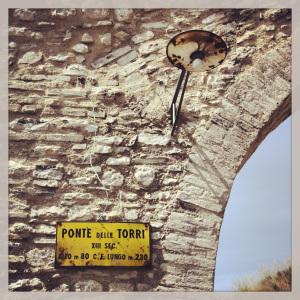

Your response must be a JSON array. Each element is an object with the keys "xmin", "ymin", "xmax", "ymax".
[{"xmin": 215, "ymin": 117, "xmax": 292, "ymax": 291}]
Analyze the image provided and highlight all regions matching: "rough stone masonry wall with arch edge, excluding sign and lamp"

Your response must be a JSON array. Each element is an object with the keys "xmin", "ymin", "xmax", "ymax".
[{"xmin": 9, "ymin": 9, "xmax": 291, "ymax": 291}]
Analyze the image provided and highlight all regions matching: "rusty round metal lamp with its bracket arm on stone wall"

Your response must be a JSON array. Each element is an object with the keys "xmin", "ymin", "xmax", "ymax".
[{"xmin": 167, "ymin": 30, "xmax": 228, "ymax": 135}]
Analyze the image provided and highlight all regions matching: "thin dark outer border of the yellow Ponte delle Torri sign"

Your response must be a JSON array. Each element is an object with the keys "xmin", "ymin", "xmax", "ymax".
[{"xmin": 54, "ymin": 221, "xmax": 153, "ymax": 271}]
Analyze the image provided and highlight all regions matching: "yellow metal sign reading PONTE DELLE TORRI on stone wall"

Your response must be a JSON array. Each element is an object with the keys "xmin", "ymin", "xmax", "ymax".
[{"xmin": 55, "ymin": 222, "xmax": 151, "ymax": 267}]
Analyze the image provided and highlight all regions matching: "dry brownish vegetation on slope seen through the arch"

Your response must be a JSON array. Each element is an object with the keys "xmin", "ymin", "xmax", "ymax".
[{"xmin": 236, "ymin": 264, "xmax": 292, "ymax": 292}]
